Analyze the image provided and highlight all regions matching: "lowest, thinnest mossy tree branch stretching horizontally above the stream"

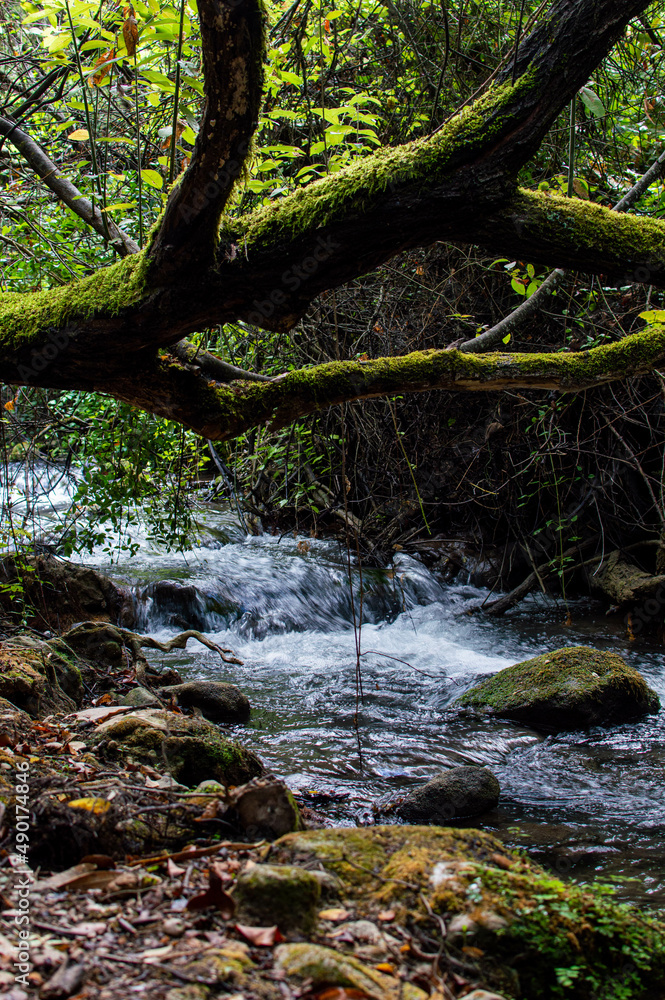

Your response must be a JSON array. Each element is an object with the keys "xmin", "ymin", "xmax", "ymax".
[{"xmin": 98, "ymin": 326, "xmax": 665, "ymax": 441}]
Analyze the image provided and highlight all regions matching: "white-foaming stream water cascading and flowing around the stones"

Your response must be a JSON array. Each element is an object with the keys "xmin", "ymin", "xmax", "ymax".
[{"xmin": 5, "ymin": 464, "xmax": 665, "ymax": 907}]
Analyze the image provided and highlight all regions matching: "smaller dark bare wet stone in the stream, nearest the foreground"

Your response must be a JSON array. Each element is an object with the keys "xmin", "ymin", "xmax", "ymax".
[{"xmin": 397, "ymin": 767, "xmax": 501, "ymax": 826}]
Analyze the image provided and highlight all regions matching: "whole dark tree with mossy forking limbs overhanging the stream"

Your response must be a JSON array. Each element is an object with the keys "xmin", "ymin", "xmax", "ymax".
[{"xmin": 0, "ymin": 0, "xmax": 665, "ymax": 422}]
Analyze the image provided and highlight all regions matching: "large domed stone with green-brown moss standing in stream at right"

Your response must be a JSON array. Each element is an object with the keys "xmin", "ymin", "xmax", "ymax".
[{"xmin": 457, "ymin": 646, "xmax": 660, "ymax": 732}]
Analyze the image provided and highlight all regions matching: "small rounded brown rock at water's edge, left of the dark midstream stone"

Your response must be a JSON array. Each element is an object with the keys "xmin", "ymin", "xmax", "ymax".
[{"xmin": 228, "ymin": 776, "xmax": 302, "ymax": 840}]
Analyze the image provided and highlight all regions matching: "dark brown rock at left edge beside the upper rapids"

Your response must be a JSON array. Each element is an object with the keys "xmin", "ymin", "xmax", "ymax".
[{"xmin": 0, "ymin": 555, "xmax": 134, "ymax": 632}]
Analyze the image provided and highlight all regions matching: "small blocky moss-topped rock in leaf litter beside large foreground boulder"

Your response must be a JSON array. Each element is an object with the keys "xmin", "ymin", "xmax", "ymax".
[{"xmin": 233, "ymin": 865, "xmax": 321, "ymax": 934}]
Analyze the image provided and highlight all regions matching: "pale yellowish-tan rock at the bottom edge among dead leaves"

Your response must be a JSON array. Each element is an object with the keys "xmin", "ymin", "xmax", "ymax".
[{"xmin": 275, "ymin": 943, "xmax": 427, "ymax": 1000}]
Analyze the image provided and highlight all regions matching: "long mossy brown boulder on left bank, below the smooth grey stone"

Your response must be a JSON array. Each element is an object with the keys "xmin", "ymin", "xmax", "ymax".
[{"xmin": 89, "ymin": 709, "xmax": 263, "ymax": 786}]
